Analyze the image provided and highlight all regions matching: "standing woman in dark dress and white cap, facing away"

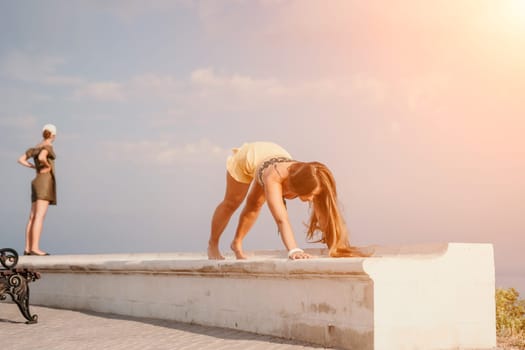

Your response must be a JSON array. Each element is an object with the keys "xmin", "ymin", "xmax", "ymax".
[{"xmin": 18, "ymin": 124, "xmax": 57, "ymax": 256}]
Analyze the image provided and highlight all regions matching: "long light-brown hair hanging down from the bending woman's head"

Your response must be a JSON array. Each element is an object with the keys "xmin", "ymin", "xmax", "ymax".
[{"xmin": 290, "ymin": 162, "xmax": 363, "ymax": 257}]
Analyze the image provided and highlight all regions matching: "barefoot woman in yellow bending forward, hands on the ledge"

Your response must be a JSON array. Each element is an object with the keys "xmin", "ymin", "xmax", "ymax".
[{"xmin": 208, "ymin": 142, "xmax": 362, "ymax": 259}]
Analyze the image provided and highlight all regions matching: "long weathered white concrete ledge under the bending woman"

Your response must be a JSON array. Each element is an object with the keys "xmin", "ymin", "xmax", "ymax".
[{"xmin": 19, "ymin": 243, "xmax": 496, "ymax": 350}]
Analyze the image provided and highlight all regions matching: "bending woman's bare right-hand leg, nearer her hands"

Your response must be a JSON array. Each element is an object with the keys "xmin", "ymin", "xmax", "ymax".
[{"xmin": 230, "ymin": 182, "xmax": 265, "ymax": 259}]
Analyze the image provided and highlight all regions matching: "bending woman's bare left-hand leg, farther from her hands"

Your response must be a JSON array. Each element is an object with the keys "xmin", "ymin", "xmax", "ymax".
[{"xmin": 208, "ymin": 172, "xmax": 250, "ymax": 260}]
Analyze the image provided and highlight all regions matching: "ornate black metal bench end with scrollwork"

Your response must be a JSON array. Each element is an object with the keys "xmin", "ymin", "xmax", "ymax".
[{"xmin": 0, "ymin": 248, "xmax": 40, "ymax": 324}]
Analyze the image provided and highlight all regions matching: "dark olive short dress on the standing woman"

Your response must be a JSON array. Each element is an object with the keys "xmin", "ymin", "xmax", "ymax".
[{"xmin": 26, "ymin": 146, "xmax": 57, "ymax": 205}]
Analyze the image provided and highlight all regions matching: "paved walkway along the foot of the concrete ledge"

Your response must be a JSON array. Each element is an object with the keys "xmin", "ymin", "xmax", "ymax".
[{"xmin": 0, "ymin": 303, "xmax": 332, "ymax": 350}]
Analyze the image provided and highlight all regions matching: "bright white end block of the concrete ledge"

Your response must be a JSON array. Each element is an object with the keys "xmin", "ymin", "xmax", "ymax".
[{"xmin": 364, "ymin": 244, "xmax": 496, "ymax": 349}]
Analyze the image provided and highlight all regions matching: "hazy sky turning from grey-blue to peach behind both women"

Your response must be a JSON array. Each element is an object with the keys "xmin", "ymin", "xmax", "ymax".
[{"xmin": 0, "ymin": 0, "xmax": 525, "ymax": 295}]
